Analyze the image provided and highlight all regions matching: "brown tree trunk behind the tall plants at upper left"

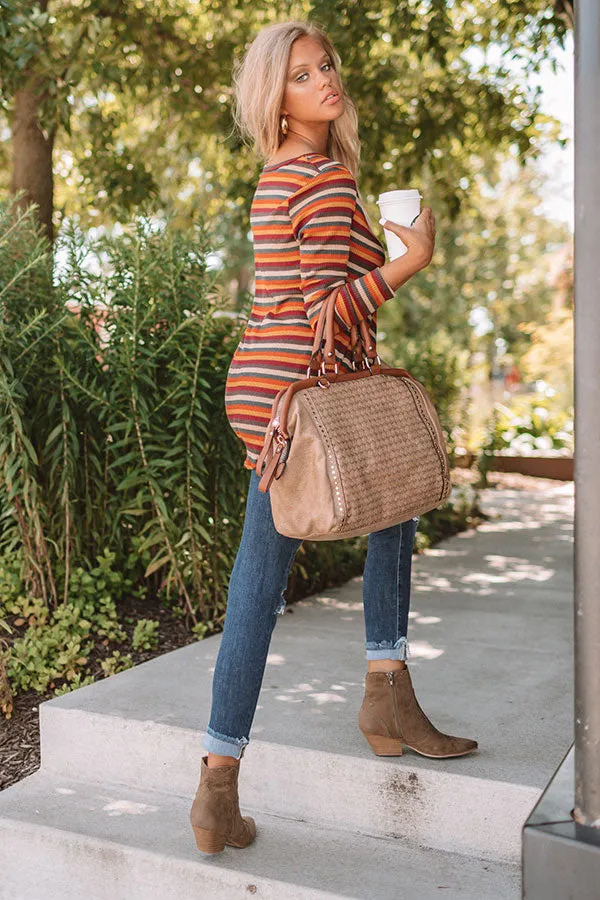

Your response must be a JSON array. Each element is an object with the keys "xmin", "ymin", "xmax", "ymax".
[{"xmin": 10, "ymin": 78, "xmax": 56, "ymax": 243}]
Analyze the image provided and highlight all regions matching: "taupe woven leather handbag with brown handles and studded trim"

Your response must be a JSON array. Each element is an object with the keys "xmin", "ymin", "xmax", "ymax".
[{"xmin": 256, "ymin": 289, "xmax": 452, "ymax": 541}]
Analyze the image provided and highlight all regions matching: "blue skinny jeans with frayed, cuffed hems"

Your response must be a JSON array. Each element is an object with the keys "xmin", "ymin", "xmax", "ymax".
[{"xmin": 202, "ymin": 469, "xmax": 420, "ymax": 759}]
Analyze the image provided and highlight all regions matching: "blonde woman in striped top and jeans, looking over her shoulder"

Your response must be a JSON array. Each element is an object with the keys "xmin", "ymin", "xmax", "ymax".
[{"xmin": 190, "ymin": 21, "xmax": 477, "ymax": 853}]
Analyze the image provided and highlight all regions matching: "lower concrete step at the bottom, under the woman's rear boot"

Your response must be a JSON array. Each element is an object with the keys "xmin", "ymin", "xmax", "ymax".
[{"xmin": 0, "ymin": 771, "xmax": 521, "ymax": 900}]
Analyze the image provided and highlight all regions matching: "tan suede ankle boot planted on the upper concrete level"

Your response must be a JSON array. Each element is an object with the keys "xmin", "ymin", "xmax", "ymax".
[{"xmin": 358, "ymin": 667, "xmax": 477, "ymax": 758}]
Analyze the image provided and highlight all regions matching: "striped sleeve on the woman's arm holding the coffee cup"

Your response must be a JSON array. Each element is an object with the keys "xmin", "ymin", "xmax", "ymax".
[{"xmin": 288, "ymin": 163, "xmax": 394, "ymax": 331}]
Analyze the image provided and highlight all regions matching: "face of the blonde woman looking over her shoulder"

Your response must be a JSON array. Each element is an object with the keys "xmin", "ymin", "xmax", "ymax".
[{"xmin": 281, "ymin": 35, "xmax": 344, "ymax": 122}]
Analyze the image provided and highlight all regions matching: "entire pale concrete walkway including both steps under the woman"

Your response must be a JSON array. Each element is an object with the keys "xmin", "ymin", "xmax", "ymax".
[{"xmin": 0, "ymin": 482, "xmax": 573, "ymax": 900}]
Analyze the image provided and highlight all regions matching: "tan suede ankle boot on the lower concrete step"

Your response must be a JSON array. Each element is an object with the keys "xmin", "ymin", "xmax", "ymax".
[{"xmin": 190, "ymin": 756, "xmax": 256, "ymax": 853}]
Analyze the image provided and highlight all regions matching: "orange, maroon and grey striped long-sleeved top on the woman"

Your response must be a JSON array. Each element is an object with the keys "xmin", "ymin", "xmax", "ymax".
[{"xmin": 225, "ymin": 152, "xmax": 394, "ymax": 469}]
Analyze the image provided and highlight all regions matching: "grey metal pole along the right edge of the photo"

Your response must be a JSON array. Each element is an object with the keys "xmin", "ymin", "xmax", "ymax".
[{"xmin": 573, "ymin": 0, "xmax": 600, "ymax": 828}]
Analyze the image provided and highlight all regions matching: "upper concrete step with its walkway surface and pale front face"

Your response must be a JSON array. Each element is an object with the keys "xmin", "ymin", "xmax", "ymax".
[{"xmin": 34, "ymin": 484, "xmax": 573, "ymax": 862}]
